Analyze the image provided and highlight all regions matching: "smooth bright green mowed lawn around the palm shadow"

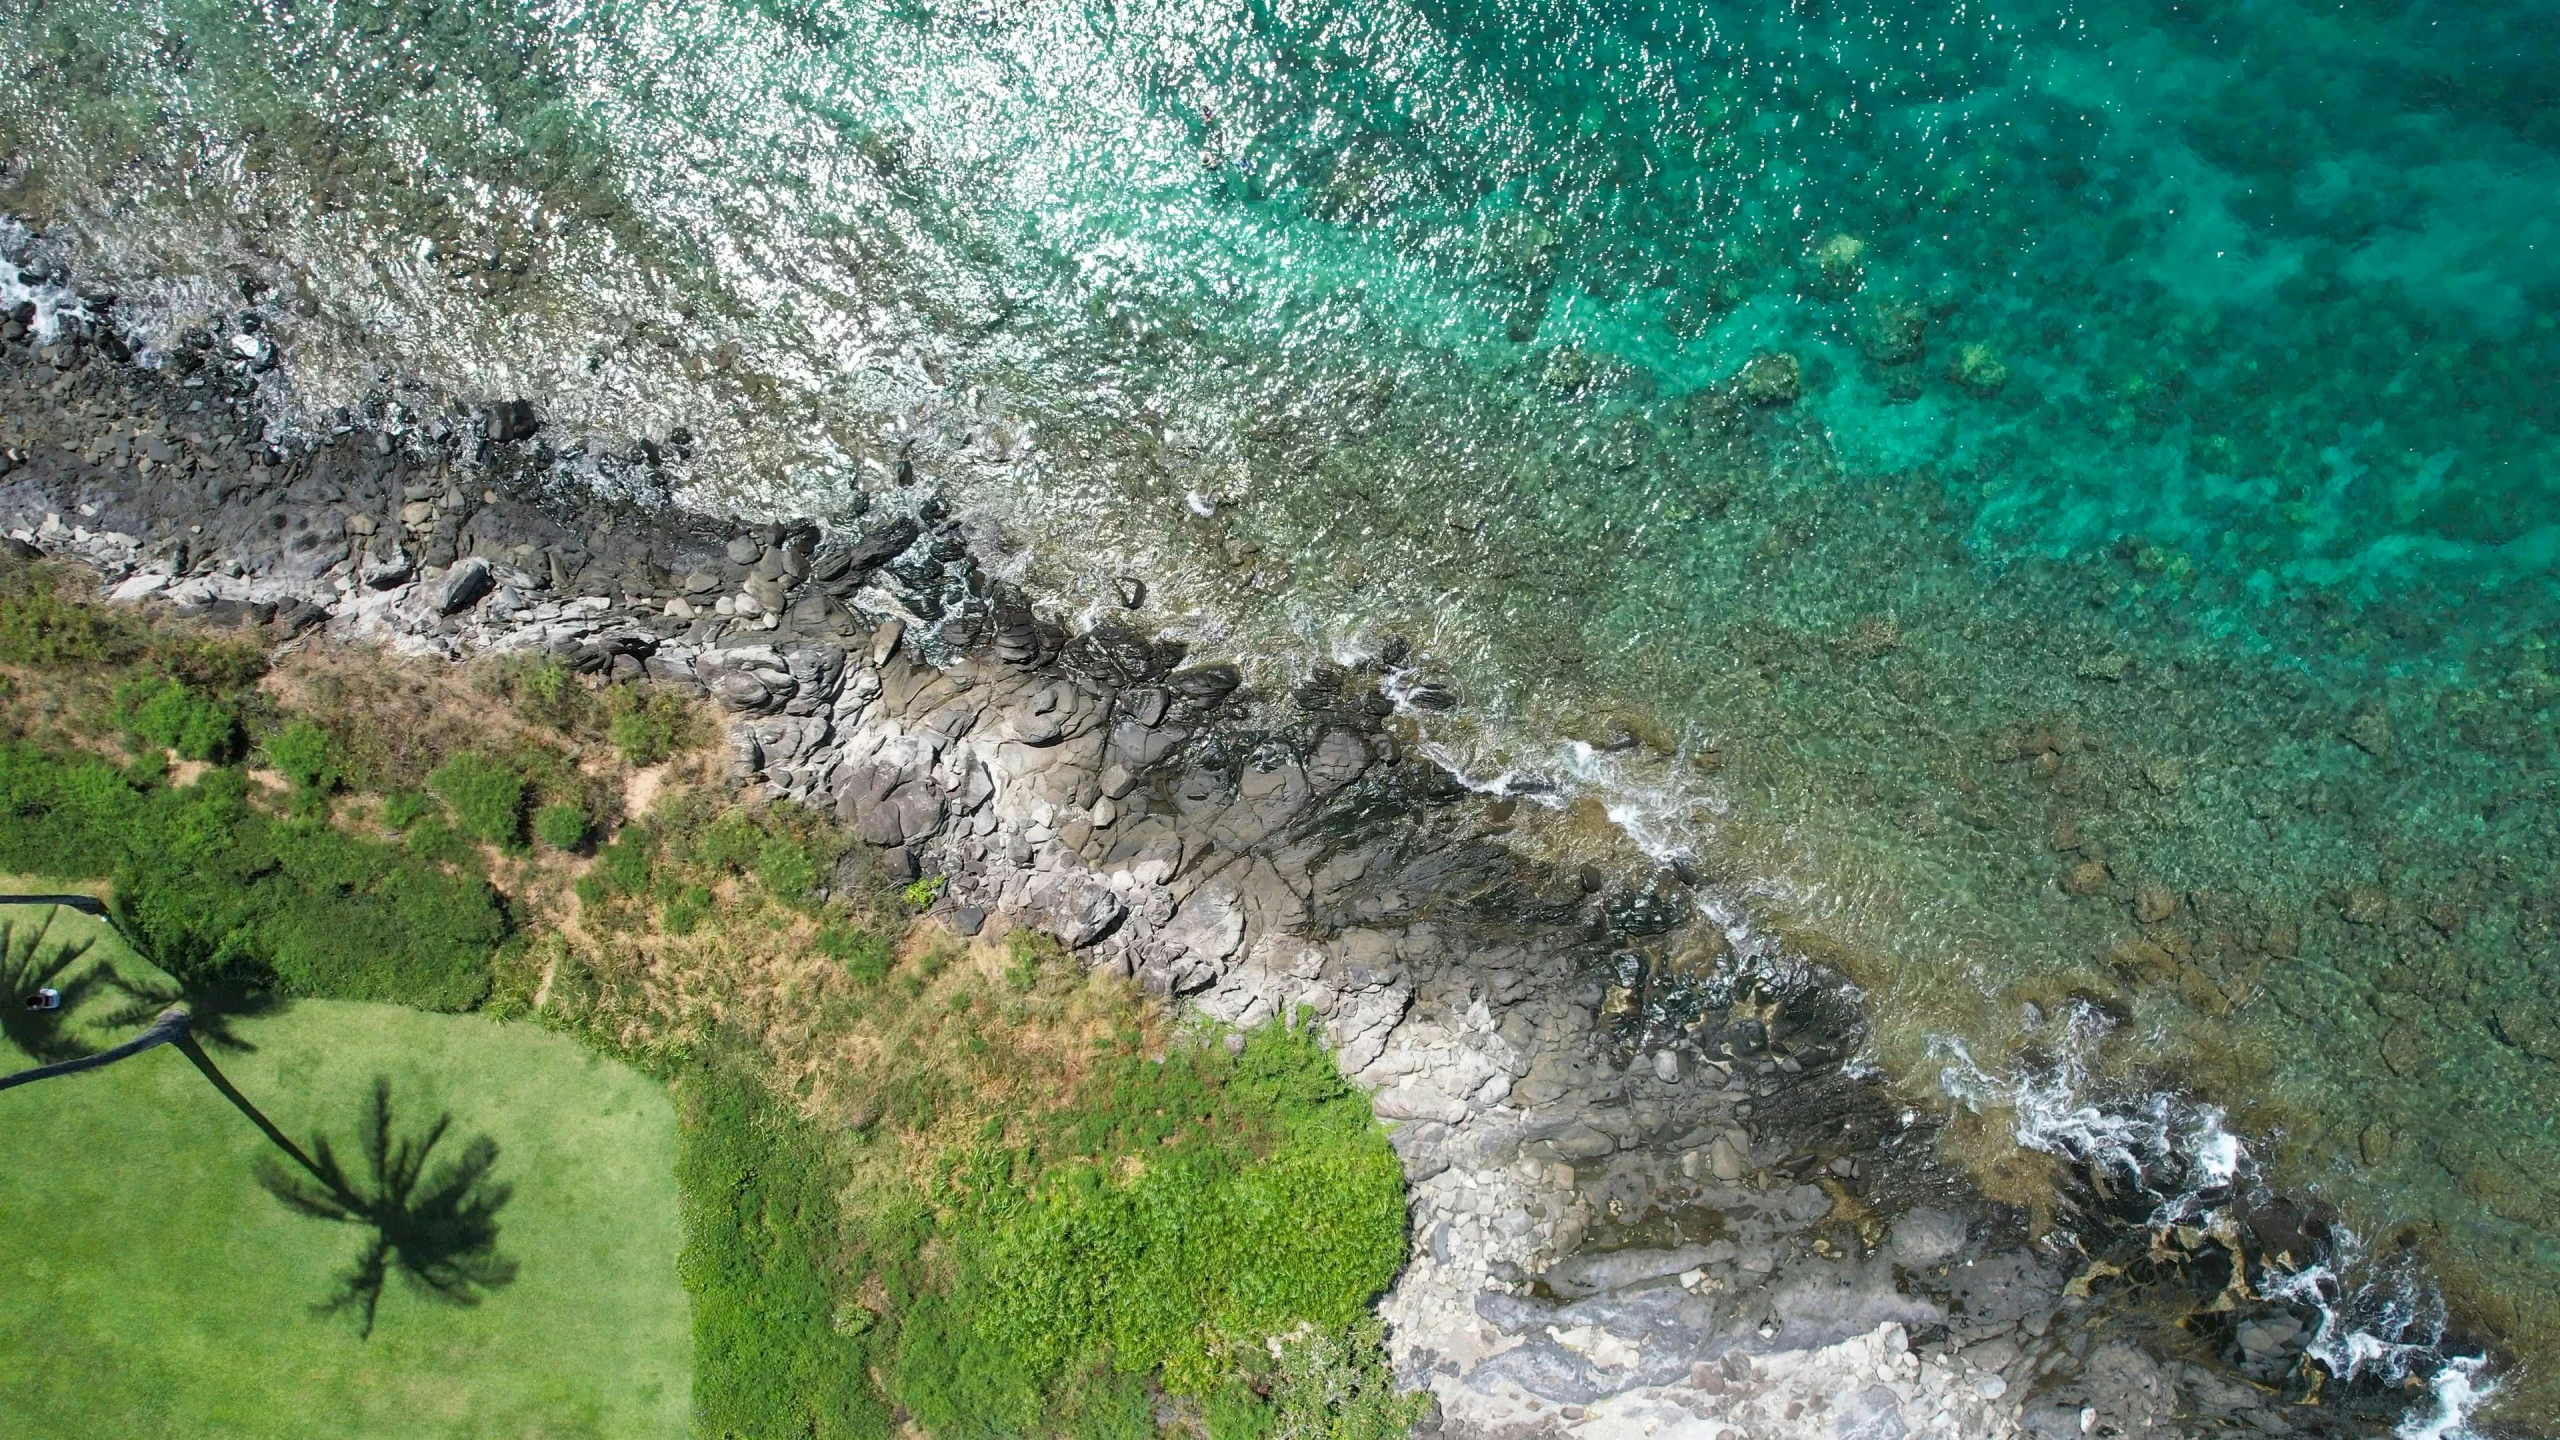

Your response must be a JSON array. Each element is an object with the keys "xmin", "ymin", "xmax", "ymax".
[{"xmin": 0, "ymin": 937, "xmax": 691, "ymax": 1440}]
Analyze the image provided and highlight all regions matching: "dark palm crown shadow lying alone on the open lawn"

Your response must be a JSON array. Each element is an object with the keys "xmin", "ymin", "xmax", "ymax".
[{"xmin": 259, "ymin": 1076, "xmax": 515, "ymax": 1338}]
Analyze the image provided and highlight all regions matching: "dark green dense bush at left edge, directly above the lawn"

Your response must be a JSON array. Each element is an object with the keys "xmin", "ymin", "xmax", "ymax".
[{"xmin": 0, "ymin": 743, "xmax": 507, "ymax": 1010}]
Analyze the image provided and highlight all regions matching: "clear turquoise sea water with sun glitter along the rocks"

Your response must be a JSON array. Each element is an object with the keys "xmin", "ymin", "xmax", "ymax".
[{"xmin": 0, "ymin": 0, "xmax": 2560, "ymax": 1407}]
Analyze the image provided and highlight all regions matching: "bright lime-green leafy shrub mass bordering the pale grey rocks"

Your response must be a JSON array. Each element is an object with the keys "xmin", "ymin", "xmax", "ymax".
[{"xmin": 876, "ymin": 1025, "xmax": 1411, "ymax": 1440}]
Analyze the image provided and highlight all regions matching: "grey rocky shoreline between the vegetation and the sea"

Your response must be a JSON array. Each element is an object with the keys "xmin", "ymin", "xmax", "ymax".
[{"xmin": 0, "ymin": 277, "xmax": 2406, "ymax": 1440}]
